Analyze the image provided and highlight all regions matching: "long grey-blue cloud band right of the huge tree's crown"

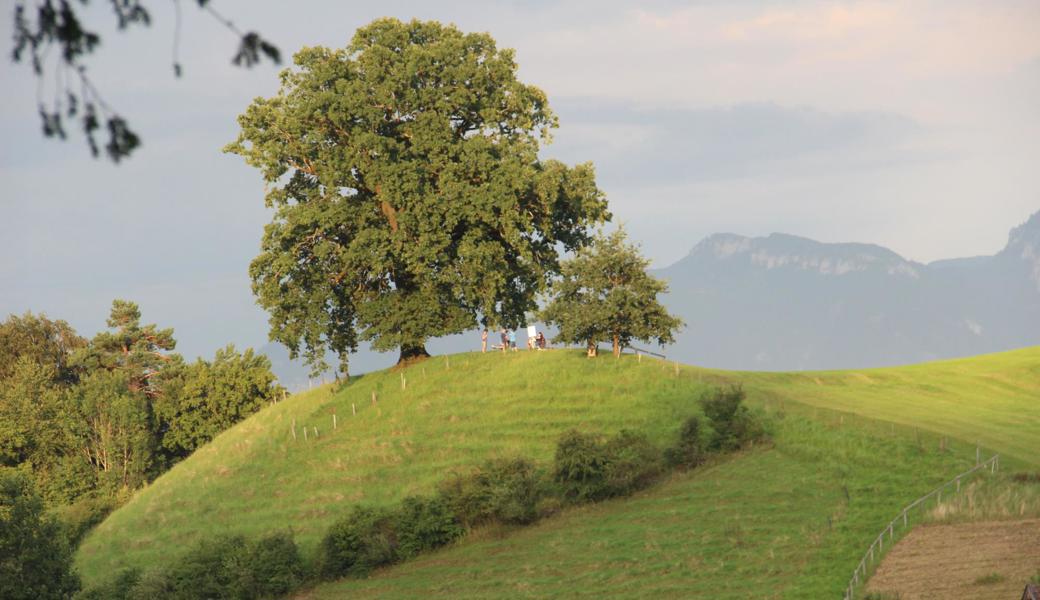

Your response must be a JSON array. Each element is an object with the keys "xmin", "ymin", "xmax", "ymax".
[{"xmin": 546, "ymin": 98, "xmax": 924, "ymax": 188}]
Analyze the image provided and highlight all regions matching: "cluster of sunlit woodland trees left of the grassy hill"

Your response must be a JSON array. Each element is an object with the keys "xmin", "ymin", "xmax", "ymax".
[{"xmin": 0, "ymin": 301, "xmax": 281, "ymax": 505}]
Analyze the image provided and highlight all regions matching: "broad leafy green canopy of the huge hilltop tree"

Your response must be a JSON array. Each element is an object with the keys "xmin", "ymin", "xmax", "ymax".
[{"xmin": 226, "ymin": 19, "xmax": 609, "ymax": 370}]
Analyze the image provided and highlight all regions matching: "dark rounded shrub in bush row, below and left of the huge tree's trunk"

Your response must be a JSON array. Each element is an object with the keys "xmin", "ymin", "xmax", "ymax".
[{"xmin": 318, "ymin": 506, "xmax": 399, "ymax": 579}]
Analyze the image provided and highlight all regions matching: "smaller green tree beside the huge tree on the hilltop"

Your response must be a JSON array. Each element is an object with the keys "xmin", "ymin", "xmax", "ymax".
[{"xmin": 540, "ymin": 229, "xmax": 683, "ymax": 357}]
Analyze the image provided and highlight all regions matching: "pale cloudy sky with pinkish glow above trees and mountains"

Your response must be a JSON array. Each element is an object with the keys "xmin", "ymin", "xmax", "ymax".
[{"xmin": 0, "ymin": 0, "xmax": 1040, "ymax": 358}]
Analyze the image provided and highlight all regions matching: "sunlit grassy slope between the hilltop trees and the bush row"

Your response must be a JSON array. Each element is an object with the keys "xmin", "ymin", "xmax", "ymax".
[{"xmin": 77, "ymin": 351, "xmax": 715, "ymax": 582}]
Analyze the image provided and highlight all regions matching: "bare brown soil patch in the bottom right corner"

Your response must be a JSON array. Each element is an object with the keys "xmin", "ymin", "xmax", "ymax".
[{"xmin": 866, "ymin": 519, "xmax": 1040, "ymax": 600}]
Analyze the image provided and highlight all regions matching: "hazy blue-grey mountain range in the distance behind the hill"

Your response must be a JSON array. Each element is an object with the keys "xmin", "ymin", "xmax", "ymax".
[{"xmin": 261, "ymin": 212, "xmax": 1040, "ymax": 382}]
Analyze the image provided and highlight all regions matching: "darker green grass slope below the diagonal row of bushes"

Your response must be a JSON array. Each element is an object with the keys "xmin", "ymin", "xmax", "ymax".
[{"xmin": 306, "ymin": 407, "xmax": 973, "ymax": 599}]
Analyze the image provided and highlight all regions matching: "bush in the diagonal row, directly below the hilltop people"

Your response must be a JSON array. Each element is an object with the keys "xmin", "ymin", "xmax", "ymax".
[{"xmin": 440, "ymin": 458, "xmax": 544, "ymax": 527}]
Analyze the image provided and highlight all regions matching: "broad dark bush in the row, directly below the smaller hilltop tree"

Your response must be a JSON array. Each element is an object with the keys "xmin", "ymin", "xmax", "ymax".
[{"xmin": 552, "ymin": 429, "xmax": 662, "ymax": 503}]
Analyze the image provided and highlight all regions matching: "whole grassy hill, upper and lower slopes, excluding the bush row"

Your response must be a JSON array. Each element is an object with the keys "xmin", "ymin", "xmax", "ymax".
[{"xmin": 77, "ymin": 348, "xmax": 1040, "ymax": 598}]
